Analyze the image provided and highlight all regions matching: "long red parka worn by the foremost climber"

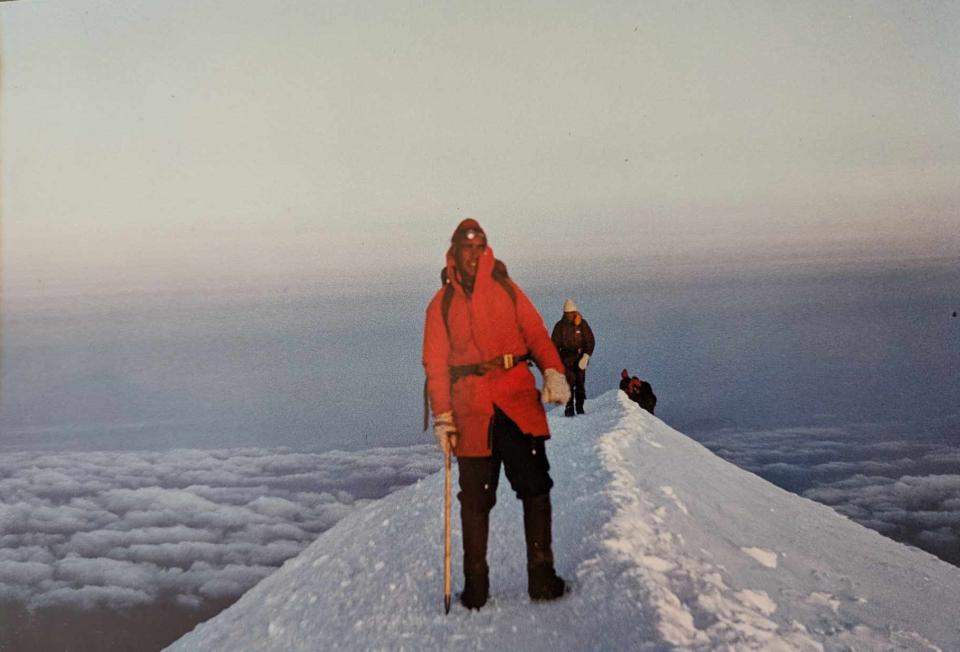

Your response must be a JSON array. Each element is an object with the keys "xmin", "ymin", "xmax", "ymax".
[{"xmin": 423, "ymin": 246, "xmax": 564, "ymax": 457}]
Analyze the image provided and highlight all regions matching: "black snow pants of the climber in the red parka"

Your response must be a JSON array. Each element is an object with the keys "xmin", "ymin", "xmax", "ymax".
[{"xmin": 457, "ymin": 408, "xmax": 553, "ymax": 579}]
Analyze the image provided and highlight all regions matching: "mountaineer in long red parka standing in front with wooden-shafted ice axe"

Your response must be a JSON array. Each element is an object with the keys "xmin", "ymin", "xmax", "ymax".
[{"xmin": 423, "ymin": 219, "xmax": 570, "ymax": 609}]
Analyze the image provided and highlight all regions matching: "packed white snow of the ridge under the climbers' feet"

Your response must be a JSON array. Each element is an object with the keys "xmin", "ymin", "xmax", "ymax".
[{"xmin": 169, "ymin": 391, "xmax": 960, "ymax": 652}]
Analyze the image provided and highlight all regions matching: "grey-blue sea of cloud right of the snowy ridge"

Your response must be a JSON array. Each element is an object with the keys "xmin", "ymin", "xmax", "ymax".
[{"xmin": 698, "ymin": 424, "xmax": 960, "ymax": 566}]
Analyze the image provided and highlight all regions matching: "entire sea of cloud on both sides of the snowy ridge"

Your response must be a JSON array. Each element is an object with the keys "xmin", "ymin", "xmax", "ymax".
[{"xmin": 0, "ymin": 424, "xmax": 960, "ymax": 609}]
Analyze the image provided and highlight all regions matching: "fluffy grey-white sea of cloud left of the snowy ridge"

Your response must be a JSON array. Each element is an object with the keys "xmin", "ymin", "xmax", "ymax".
[{"xmin": 0, "ymin": 445, "xmax": 440, "ymax": 608}]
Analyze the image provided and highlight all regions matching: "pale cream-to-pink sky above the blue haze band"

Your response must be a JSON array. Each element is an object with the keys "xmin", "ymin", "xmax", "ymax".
[{"xmin": 0, "ymin": 0, "xmax": 960, "ymax": 292}]
